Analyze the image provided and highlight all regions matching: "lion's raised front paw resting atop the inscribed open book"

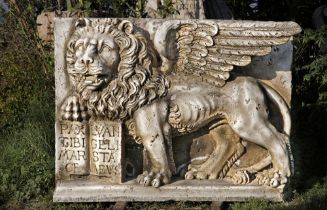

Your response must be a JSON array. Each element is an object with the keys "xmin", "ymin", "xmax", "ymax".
[{"xmin": 61, "ymin": 95, "xmax": 88, "ymax": 121}]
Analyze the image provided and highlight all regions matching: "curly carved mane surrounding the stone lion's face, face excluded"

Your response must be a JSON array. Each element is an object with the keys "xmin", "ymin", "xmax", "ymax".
[{"xmin": 66, "ymin": 19, "xmax": 169, "ymax": 120}]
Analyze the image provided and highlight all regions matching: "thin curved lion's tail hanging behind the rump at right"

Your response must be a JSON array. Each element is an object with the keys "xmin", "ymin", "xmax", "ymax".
[{"xmin": 260, "ymin": 82, "xmax": 294, "ymax": 174}]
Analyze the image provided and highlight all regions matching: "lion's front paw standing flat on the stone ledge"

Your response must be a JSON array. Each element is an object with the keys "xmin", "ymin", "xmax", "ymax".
[{"xmin": 136, "ymin": 171, "xmax": 170, "ymax": 187}]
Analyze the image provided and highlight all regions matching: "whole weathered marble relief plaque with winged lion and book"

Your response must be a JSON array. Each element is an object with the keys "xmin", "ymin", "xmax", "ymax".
[{"xmin": 54, "ymin": 18, "xmax": 301, "ymax": 201}]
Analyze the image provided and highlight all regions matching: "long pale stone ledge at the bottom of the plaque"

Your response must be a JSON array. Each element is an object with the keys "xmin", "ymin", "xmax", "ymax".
[{"xmin": 53, "ymin": 180, "xmax": 283, "ymax": 202}]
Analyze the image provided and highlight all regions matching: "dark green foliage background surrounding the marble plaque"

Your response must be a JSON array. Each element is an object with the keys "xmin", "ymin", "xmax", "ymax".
[{"xmin": 0, "ymin": 0, "xmax": 327, "ymax": 209}]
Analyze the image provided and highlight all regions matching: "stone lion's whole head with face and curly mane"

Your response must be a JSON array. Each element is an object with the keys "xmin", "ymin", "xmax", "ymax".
[{"xmin": 66, "ymin": 19, "xmax": 169, "ymax": 120}]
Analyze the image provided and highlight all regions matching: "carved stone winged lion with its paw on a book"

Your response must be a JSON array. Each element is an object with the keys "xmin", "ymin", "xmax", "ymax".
[{"xmin": 61, "ymin": 19, "xmax": 301, "ymax": 187}]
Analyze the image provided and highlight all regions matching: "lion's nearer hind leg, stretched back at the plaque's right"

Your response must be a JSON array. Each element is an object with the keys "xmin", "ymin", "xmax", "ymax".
[{"xmin": 227, "ymin": 78, "xmax": 291, "ymax": 185}]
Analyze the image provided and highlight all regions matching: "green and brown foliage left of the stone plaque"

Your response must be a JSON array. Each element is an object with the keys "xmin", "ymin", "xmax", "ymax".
[{"xmin": 0, "ymin": 0, "xmax": 54, "ymax": 202}]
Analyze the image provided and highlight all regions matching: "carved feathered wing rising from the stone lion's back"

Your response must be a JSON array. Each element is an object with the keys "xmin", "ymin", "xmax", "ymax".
[{"xmin": 154, "ymin": 20, "xmax": 301, "ymax": 86}]
